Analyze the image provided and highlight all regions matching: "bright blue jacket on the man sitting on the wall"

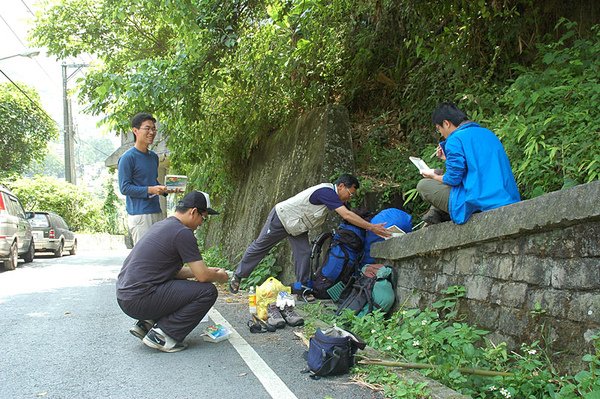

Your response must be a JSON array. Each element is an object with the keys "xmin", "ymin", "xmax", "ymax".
[{"xmin": 442, "ymin": 122, "xmax": 521, "ymax": 224}]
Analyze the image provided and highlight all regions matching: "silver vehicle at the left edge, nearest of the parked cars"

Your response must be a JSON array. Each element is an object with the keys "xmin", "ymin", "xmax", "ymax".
[{"xmin": 0, "ymin": 185, "xmax": 35, "ymax": 270}]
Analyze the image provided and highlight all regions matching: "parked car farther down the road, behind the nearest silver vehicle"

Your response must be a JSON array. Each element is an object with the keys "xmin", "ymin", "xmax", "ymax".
[{"xmin": 27, "ymin": 212, "xmax": 77, "ymax": 256}]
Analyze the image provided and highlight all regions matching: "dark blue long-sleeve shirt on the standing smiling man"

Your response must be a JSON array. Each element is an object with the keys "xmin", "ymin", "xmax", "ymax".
[{"xmin": 118, "ymin": 147, "xmax": 161, "ymax": 215}]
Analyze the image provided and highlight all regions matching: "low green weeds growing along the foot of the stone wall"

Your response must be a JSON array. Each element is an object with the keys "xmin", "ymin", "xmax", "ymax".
[{"xmin": 304, "ymin": 286, "xmax": 600, "ymax": 399}]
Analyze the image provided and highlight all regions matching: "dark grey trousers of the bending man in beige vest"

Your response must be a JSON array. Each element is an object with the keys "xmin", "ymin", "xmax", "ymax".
[{"xmin": 235, "ymin": 208, "xmax": 311, "ymax": 283}]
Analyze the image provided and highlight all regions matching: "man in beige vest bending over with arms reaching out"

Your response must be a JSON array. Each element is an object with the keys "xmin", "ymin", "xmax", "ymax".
[{"xmin": 229, "ymin": 174, "xmax": 390, "ymax": 293}]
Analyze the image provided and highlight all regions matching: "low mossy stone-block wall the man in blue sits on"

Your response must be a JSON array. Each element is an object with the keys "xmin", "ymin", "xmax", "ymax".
[{"xmin": 371, "ymin": 181, "xmax": 600, "ymax": 370}]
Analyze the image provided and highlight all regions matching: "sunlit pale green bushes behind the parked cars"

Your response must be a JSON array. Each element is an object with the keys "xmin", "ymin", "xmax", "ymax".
[{"xmin": 8, "ymin": 176, "xmax": 105, "ymax": 232}]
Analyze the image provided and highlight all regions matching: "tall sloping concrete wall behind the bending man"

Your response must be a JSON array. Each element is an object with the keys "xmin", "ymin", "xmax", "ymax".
[{"xmin": 206, "ymin": 105, "xmax": 354, "ymax": 283}]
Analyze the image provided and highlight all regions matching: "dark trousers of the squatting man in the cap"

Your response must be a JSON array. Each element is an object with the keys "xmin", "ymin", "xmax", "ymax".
[{"xmin": 117, "ymin": 280, "xmax": 218, "ymax": 342}]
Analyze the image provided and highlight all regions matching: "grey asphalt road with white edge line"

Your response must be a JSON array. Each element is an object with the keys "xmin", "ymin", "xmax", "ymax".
[{"xmin": 0, "ymin": 251, "xmax": 381, "ymax": 399}]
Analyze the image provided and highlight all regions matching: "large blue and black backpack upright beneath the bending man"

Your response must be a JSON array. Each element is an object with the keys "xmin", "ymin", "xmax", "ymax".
[{"xmin": 311, "ymin": 223, "xmax": 365, "ymax": 299}]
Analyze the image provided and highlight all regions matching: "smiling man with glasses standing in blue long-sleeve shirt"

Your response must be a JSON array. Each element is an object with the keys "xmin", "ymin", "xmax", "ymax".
[{"xmin": 118, "ymin": 112, "xmax": 180, "ymax": 245}]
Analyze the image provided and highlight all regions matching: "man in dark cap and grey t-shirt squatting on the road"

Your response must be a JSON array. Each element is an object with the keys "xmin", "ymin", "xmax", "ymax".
[{"xmin": 117, "ymin": 191, "xmax": 228, "ymax": 352}]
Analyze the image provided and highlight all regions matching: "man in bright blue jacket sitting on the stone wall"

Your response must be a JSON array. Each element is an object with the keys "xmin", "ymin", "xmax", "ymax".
[{"xmin": 417, "ymin": 103, "xmax": 521, "ymax": 224}]
